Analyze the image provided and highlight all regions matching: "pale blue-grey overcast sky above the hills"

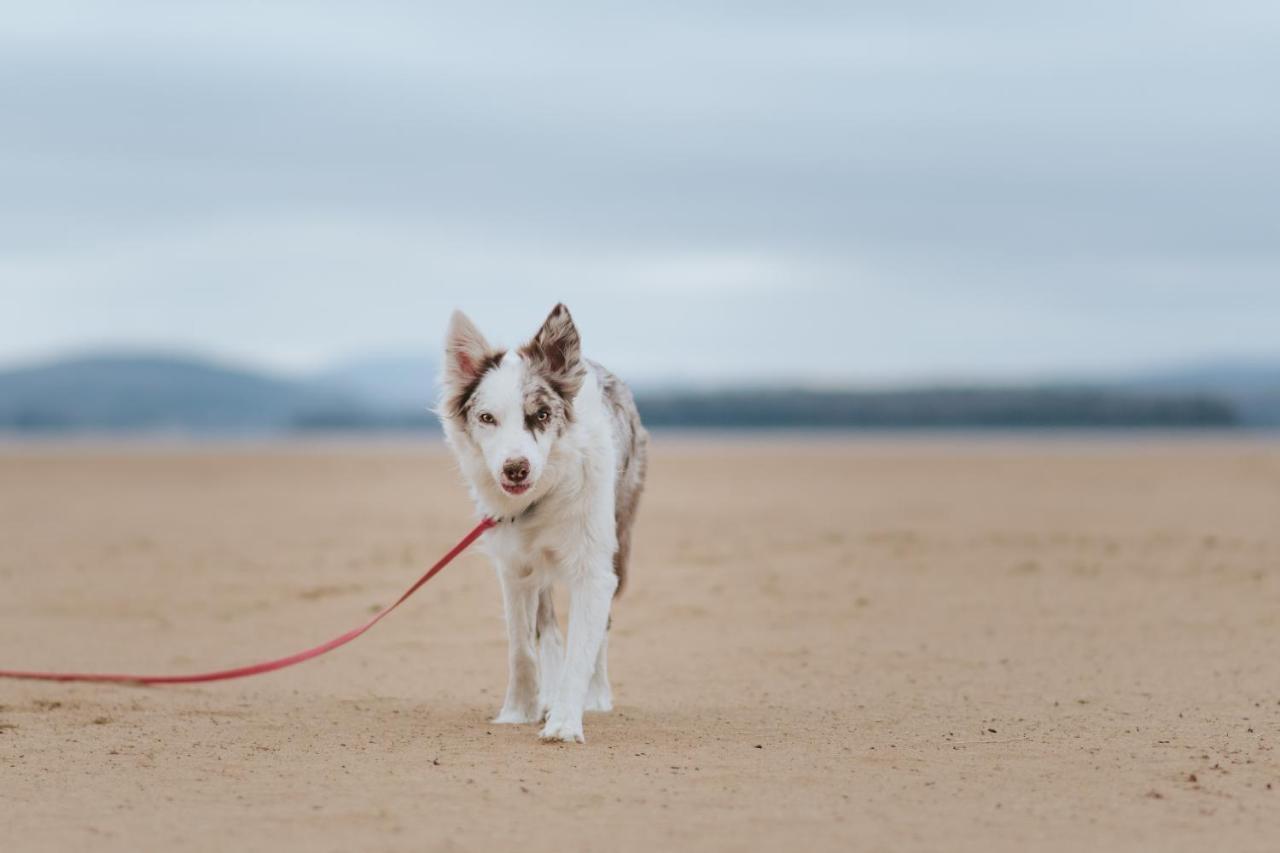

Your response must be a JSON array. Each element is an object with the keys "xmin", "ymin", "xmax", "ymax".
[{"xmin": 0, "ymin": 0, "xmax": 1280, "ymax": 383}]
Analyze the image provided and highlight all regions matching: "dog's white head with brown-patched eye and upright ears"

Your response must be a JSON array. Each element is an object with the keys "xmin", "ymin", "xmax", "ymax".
[{"xmin": 440, "ymin": 305, "xmax": 586, "ymax": 503}]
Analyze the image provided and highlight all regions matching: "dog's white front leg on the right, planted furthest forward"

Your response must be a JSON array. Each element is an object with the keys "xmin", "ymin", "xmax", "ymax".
[{"xmin": 541, "ymin": 556, "xmax": 618, "ymax": 743}]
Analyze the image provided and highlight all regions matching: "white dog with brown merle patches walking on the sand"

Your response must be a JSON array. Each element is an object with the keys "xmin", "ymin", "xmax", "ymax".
[{"xmin": 438, "ymin": 304, "xmax": 649, "ymax": 743}]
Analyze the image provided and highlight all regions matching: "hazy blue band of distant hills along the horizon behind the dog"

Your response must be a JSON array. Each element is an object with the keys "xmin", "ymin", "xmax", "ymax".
[{"xmin": 0, "ymin": 353, "xmax": 1259, "ymax": 434}]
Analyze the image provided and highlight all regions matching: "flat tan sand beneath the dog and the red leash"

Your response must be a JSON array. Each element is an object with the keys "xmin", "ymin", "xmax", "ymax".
[{"xmin": 0, "ymin": 437, "xmax": 1280, "ymax": 853}]
